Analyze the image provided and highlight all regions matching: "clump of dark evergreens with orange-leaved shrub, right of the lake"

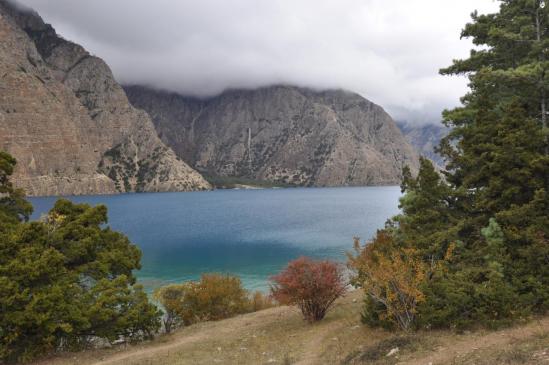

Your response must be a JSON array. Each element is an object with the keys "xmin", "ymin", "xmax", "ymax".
[{"xmin": 351, "ymin": 0, "xmax": 549, "ymax": 329}]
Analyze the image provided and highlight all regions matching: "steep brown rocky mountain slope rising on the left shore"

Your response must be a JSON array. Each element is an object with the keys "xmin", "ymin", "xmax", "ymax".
[{"xmin": 0, "ymin": 0, "xmax": 210, "ymax": 195}]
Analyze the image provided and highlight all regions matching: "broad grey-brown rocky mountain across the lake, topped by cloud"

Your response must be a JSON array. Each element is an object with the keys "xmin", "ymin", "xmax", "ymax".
[{"xmin": 126, "ymin": 86, "xmax": 418, "ymax": 186}]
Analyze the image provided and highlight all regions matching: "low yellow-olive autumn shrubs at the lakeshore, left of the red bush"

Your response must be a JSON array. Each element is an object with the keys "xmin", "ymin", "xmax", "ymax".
[{"xmin": 154, "ymin": 274, "xmax": 274, "ymax": 332}]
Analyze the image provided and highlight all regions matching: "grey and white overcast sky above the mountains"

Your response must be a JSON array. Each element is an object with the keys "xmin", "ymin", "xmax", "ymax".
[{"xmin": 19, "ymin": 0, "xmax": 498, "ymax": 123}]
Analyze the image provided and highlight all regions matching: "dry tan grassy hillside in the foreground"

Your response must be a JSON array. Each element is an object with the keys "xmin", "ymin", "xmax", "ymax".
[{"xmin": 32, "ymin": 291, "xmax": 549, "ymax": 365}]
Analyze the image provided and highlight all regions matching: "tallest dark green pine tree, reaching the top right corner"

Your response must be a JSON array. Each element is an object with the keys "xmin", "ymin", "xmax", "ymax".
[{"xmin": 440, "ymin": 0, "xmax": 549, "ymax": 311}]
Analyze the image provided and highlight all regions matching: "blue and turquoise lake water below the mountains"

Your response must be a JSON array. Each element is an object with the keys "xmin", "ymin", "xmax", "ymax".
[{"xmin": 30, "ymin": 186, "xmax": 400, "ymax": 291}]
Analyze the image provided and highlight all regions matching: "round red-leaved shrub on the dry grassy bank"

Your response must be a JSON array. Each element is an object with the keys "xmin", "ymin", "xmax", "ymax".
[{"xmin": 271, "ymin": 257, "xmax": 347, "ymax": 323}]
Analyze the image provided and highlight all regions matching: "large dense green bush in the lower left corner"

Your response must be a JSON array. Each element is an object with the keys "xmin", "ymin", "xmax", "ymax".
[{"xmin": 0, "ymin": 154, "xmax": 161, "ymax": 362}]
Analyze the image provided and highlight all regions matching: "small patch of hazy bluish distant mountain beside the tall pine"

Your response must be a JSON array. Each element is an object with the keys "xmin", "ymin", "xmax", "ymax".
[{"xmin": 397, "ymin": 121, "xmax": 450, "ymax": 167}]
